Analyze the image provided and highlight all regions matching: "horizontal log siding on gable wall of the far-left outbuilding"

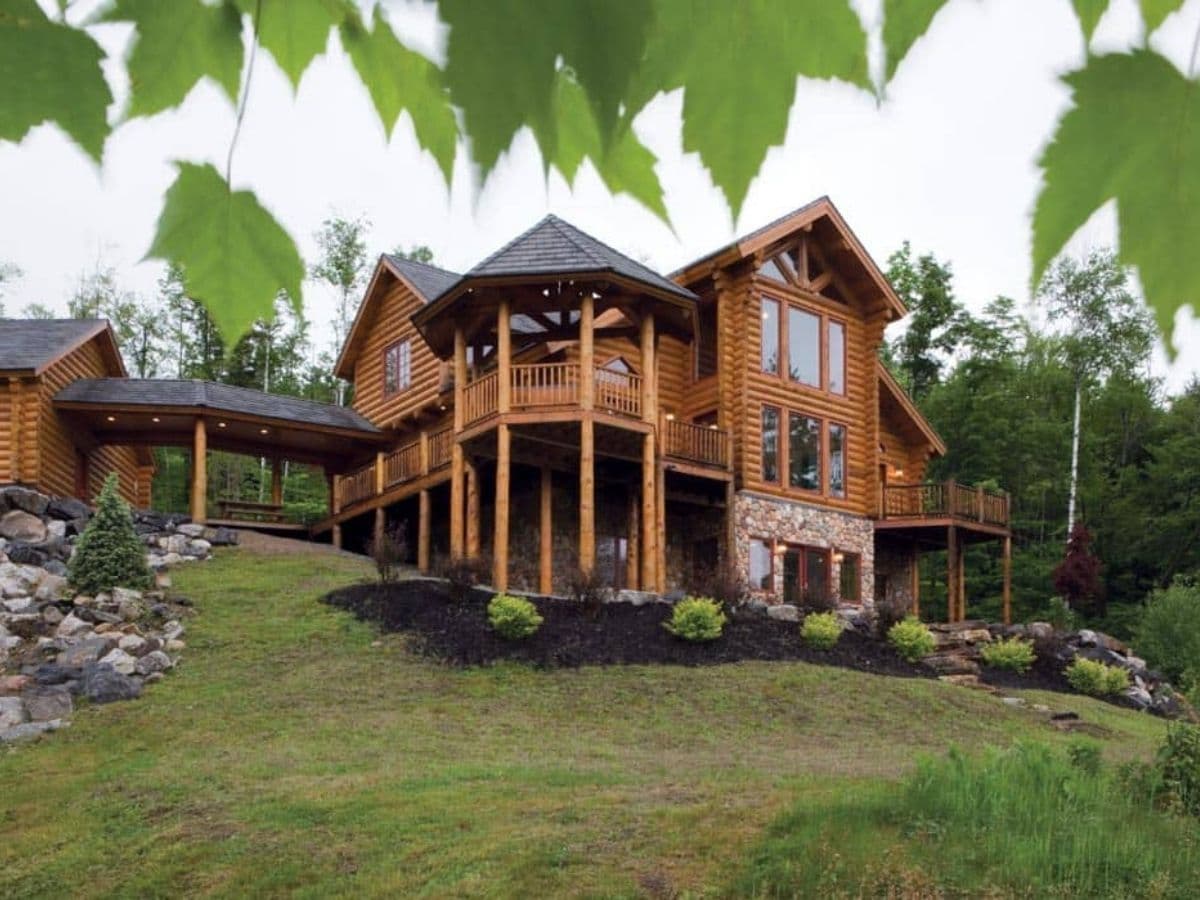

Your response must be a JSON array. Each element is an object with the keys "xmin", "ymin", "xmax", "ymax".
[{"xmin": 36, "ymin": 341, "xmax": 139, "ymax": 504}]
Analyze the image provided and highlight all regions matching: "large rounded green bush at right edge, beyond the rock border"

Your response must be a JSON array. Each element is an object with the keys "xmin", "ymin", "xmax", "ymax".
[{"xmin": 1133, "ymin": 577, "xmax": 1200, "ymax": 691}]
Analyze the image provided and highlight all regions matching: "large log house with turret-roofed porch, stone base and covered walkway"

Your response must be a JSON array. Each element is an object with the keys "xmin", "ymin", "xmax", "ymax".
[{"xmin": 0, "ymin": 198, "xmax": 1012, "ymax": 620}]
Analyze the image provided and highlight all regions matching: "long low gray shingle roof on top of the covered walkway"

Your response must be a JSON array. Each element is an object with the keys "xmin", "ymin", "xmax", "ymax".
[{"xmin": 54, "ymin": 378, "xmax": 380, "ymax": 434}]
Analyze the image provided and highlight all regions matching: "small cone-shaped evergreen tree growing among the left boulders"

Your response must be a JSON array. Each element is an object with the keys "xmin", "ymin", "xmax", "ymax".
[{"xmin": 67, "ymin": 473, "xmax": 150, "ymax": 594}]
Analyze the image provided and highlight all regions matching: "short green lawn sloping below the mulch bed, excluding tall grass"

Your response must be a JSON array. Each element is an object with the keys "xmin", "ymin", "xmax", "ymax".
[{"xmin": 0, "ymin": 551, "xmax": 1163, "ymax": 898}]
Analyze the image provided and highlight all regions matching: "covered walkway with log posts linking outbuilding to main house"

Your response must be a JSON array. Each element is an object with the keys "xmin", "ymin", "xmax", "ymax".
[{"xmin": 54, "ymin": 378, "xmax": 388, "ymax": 527}]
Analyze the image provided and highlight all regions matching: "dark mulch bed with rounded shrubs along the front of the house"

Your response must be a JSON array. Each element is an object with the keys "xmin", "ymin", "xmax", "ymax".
[{"xmin": 325, "ymin": 581, "xmax": 932, "ymax": 678}]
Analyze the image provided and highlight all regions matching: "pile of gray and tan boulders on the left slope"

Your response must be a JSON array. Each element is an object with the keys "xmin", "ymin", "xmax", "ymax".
[{"xmin": 0, "ymin": 487, "xmax": 238, "ymax": 743}]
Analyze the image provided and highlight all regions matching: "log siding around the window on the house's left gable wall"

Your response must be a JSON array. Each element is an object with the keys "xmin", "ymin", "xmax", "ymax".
[{"xmin": 354, "ymin": 278, "xmax": 442, "ymax": 427}]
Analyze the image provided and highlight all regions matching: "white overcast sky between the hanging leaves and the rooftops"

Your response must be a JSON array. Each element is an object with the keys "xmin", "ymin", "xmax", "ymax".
[{"xmin": 0, "ymin": 0, "xmax": 1200, "ymax": 390}]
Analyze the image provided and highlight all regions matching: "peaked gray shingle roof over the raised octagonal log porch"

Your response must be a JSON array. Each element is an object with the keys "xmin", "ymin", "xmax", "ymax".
[{"xmin": 443, "ymin": 216, "xmax": 696, "ymax": 300}]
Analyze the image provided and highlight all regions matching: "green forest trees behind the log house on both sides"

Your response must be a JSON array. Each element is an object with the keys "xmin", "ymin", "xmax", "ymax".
[{"xmin": 5, "ymin": 232, "xmax": 1200, "ymax": 635}]
